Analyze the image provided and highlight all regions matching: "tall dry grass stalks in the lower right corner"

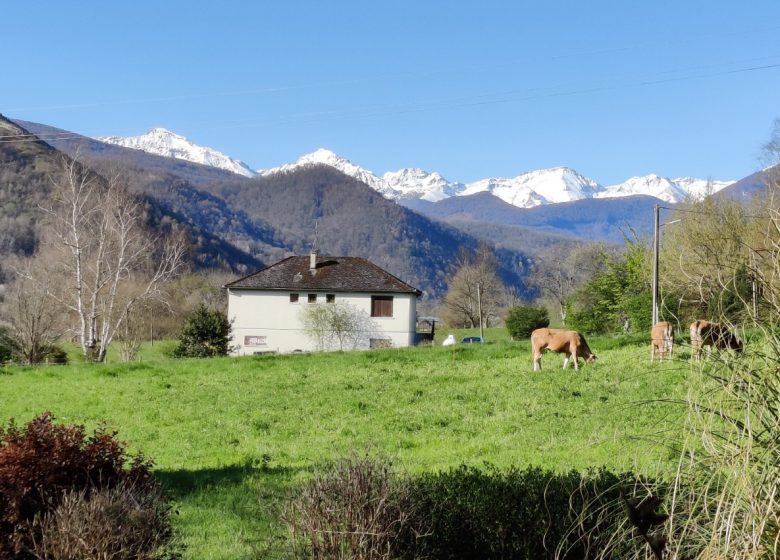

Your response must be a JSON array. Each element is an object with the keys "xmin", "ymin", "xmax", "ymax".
[{"xmin": 669, "ymin": 332, "xmax": 780, "ymax": 560}]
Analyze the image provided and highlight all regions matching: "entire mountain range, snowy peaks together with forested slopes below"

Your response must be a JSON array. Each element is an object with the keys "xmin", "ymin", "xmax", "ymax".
[{"xmin": 6, "ymin": 116, "xmax": 767, "ymax": 298}]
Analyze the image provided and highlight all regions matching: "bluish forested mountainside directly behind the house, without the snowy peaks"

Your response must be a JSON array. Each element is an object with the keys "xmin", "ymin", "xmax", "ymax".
[{"xmin": 6, "ymin": 117, "xmax": 529, "ymax": 297}]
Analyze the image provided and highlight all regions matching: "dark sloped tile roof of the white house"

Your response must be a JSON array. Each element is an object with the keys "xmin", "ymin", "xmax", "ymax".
[{"xmin": 225, "ymin": 255, "xmax": 422, "ymax": 296}]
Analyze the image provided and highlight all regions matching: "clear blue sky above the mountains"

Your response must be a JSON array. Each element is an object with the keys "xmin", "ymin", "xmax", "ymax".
[{"xmin": 0, "ymin": 0, "xmax": 780, "ymax": 185}]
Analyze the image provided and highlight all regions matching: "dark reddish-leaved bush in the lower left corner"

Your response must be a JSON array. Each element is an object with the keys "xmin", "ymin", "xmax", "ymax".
[{"xmin": 0, "ymin": 413, "xmax": 172, "ymax": 560}]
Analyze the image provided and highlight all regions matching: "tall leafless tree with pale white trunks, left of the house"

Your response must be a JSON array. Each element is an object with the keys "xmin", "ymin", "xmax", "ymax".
[{"xmin": 39, "ymin": 158, "xmax": 184, "ymax": 361}]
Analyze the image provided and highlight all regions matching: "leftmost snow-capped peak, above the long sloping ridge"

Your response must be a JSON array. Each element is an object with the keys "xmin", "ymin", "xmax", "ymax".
[{"xmin": 97, "ymin": 128, "xmax": 255, "ymax": 177}]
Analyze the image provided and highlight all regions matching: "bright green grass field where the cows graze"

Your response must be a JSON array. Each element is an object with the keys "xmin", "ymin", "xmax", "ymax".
[{"xmin": 0, "ymin": 330, "xmax": 689, "ymax": 560}]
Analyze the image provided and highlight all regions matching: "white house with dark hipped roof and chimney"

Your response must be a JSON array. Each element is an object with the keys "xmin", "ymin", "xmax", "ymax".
[{"xmin": 224, "ymin": 251, "xmax": 421, "ymax": 355}]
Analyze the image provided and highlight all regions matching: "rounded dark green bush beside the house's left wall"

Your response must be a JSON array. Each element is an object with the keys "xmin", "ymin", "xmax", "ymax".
[{"xmin": 173, "ymin": 304, "xmax": 230, "ymax": 358}]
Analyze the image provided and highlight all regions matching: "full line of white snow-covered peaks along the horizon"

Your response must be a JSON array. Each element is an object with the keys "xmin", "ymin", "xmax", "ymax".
[{"xmin": 99, "ymin": 128, "xmax": 734, "ymax": 208}]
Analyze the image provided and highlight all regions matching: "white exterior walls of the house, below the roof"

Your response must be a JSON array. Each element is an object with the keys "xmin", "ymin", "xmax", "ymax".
[{"xmin": 228, "ymin": 289, "xmax": 417, "ymax": 355}]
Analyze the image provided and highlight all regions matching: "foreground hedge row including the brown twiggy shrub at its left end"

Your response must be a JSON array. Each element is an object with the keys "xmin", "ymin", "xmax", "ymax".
[{"xmin": 287, "ymin": 458, "xmax": 647, "ymax": 560}]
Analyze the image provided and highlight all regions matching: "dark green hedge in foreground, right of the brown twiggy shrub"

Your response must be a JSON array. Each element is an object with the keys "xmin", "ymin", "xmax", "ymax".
[{"xmin": 396, "ymin": 466, "xmax": 641, "ymax": 560}]
